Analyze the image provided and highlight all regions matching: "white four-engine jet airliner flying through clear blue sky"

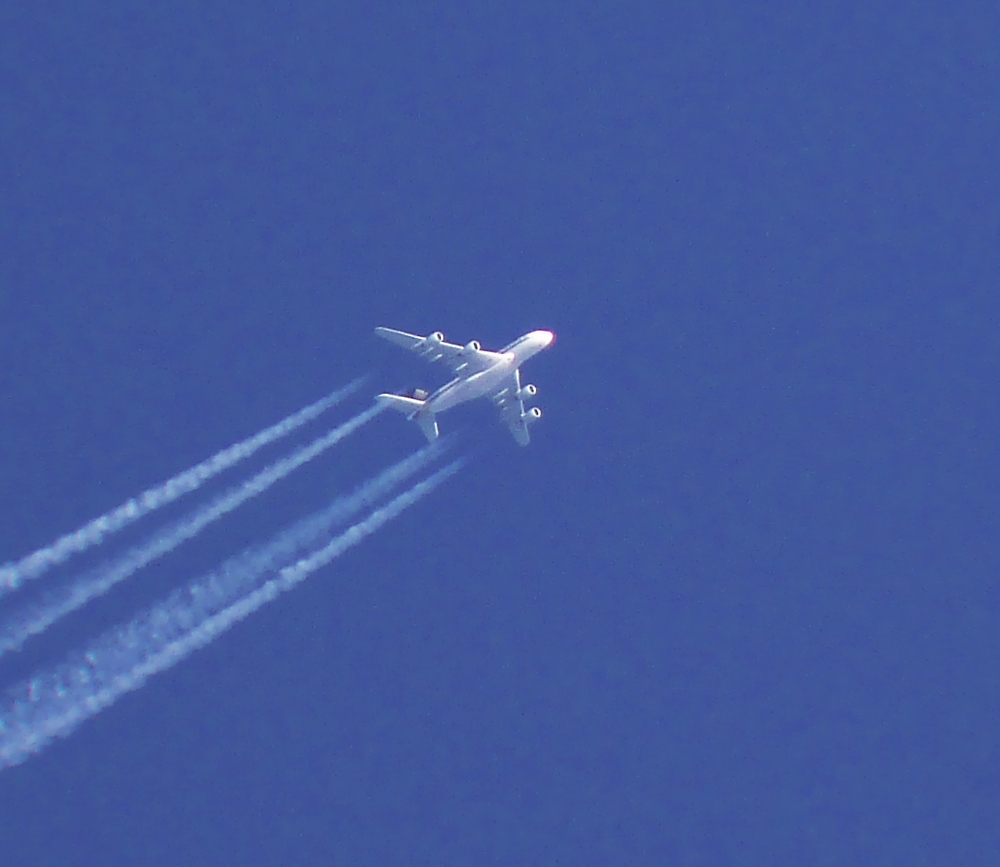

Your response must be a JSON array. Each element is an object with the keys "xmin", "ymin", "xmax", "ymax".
[{"xmin": 375, "ymin": 328, "xmax": 556, "ymax": 446}]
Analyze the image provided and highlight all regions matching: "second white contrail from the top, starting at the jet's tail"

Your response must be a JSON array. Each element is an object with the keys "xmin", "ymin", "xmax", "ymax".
[{"xmin": 0, "ymin": 404, "xmax": 385, "ymax": 656}]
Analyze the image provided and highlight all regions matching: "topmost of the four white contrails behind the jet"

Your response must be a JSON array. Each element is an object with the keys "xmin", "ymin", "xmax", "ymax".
[{"xmin": 0, "ymin": 377, "xmax": 365, "ymax": 598}]
